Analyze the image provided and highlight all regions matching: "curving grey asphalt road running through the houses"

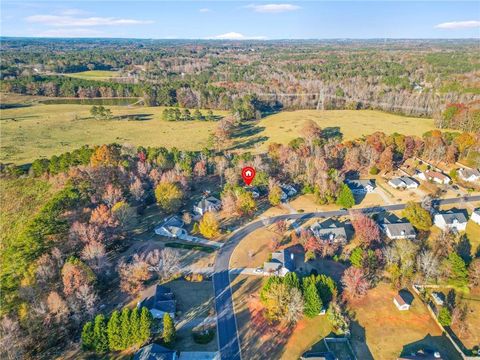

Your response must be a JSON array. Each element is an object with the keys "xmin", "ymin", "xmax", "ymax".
[{"xmin": 213, "ymin": 195, "xmax": 480, "ymax": 360}]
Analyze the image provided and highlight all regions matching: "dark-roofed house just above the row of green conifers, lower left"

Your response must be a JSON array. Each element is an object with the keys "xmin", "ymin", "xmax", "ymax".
[{"xmin": 137, "ymin": 285, "xmax": 177, "ymax": 319}]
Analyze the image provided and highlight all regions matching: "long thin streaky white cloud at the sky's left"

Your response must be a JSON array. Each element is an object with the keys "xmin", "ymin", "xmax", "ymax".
[{"xmin": 26, "ymin": 15, "xmax": 153, "ymax": 27}]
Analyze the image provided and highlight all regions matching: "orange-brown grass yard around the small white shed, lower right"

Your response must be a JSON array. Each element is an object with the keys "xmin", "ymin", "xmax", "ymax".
[{"xmin": 350, "ymin": 283, "xmax": 456, "ymax": 359}]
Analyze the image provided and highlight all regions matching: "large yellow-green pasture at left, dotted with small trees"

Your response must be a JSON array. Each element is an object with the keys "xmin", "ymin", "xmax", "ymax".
[{"xmin": 0, "ymin": 104, "xmax": 226, "ymax": 164}]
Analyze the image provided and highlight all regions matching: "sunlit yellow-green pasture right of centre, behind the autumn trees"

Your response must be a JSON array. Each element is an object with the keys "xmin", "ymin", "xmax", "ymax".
[{"xmin": 258, "ymin": 110, "xmax": 434, "ymax": 150}]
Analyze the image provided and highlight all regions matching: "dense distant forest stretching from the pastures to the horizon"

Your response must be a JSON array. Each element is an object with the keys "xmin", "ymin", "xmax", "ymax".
[{"xmin": 1, "ymin": 38, "xmax": 480, "ymax": 127}]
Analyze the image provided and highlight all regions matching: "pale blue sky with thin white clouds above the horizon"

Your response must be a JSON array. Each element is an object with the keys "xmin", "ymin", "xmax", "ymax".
[{"xmin": 0, "ymin": 0, "xmax": 480, "ymax": 40}]
